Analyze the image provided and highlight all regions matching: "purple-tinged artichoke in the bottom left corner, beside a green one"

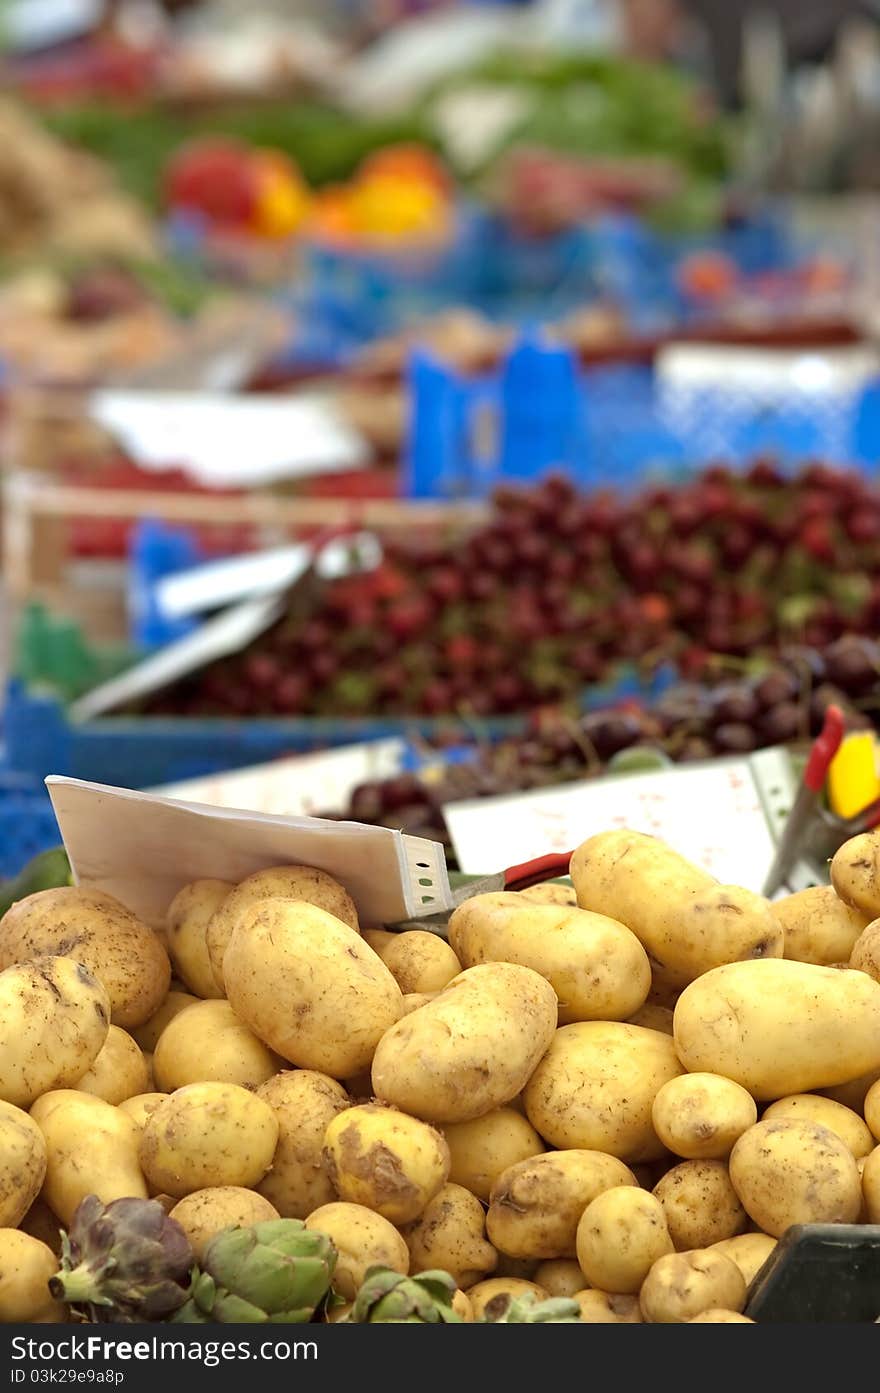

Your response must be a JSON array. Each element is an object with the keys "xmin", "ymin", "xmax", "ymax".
[{"xmin": 49, "ymin": 1195, "xmax": 194, "ymax": 1323}]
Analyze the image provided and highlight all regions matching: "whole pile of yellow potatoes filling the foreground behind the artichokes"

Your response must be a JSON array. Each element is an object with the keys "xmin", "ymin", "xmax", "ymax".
[{"xmin": 0, "ymin": 830, "xmax": 880, "ymax": 1323}]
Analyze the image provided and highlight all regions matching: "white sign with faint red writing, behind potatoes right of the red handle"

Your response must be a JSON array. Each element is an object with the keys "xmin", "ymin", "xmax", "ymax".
[{"xmin": 443, "ymin": 761, "xmax": 776, "ymax": 893}]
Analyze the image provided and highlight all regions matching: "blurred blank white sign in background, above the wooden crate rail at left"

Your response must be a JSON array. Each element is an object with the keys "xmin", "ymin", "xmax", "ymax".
[{"xmin": 89, "ymin": 390, "xmax": 370, "ymax": 488}]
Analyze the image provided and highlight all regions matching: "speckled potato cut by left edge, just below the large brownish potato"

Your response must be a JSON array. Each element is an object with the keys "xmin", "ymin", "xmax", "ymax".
[{"xmin": 0, "ymin": 957, "xmax": 110, "ymax": 1107}]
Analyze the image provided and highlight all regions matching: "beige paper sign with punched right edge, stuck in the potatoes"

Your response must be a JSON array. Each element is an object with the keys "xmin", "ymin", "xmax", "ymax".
[{"xmin": 46, "ymin": 775, "xmax": 453, "ymax": 926}]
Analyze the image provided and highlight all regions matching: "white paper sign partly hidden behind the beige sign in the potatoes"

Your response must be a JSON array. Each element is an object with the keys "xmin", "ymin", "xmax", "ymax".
[{"xmin": 152, "ymin": 740, "xmax": 407, "ymax": 818}]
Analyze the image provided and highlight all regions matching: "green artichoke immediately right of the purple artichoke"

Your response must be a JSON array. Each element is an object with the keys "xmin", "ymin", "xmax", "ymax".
[{"xmin": 173, "ymin": 1219, "xmax": 337, "ymax": 1325}]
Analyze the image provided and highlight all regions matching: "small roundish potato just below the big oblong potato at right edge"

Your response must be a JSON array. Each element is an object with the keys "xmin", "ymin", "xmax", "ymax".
[{"xmin": 650, "ymin": 1074, "xmax": 757, "ymax": 1160}]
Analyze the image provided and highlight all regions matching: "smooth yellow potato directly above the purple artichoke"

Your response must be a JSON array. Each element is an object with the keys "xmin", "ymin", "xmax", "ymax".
[{"xmin": 31, "ymin": 1088, "xmax": 148, "ymax": 1226}]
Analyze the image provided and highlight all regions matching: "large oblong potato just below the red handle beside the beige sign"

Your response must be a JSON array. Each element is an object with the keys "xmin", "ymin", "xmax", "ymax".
[{"xmin": 448, "ymin": 893, "xmax": 650, "ymax": 1025}]
